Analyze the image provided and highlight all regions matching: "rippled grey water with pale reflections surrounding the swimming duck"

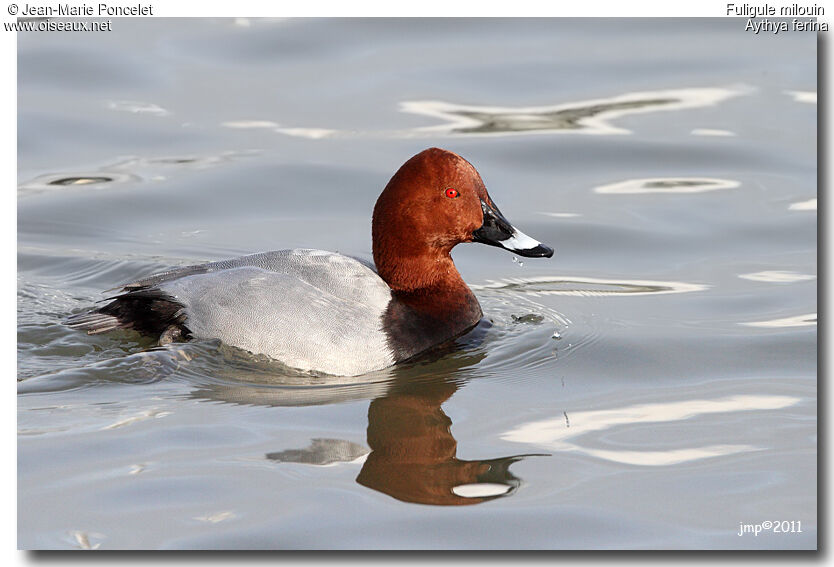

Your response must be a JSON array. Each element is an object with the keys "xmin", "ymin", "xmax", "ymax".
[{"xmin": 18, "ymin": 19, "xmax": 817, "ymax": 549}]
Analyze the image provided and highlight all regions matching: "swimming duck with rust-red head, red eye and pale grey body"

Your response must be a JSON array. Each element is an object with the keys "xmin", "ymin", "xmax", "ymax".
[{"xmin": 65, "ymin": 148, "xmax": 553, "ymax": 376}]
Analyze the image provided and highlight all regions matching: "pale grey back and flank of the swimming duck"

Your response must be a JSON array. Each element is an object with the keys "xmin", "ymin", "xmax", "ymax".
[{"xmin": 71, "ymin": 249, "xmax": 395, "ymax": 375}]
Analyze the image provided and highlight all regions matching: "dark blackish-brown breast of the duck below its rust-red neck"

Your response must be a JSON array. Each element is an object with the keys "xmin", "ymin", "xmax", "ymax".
[{"xmin": 383, "ymin": 288, "xmax": 483, "ymax": 362}]
